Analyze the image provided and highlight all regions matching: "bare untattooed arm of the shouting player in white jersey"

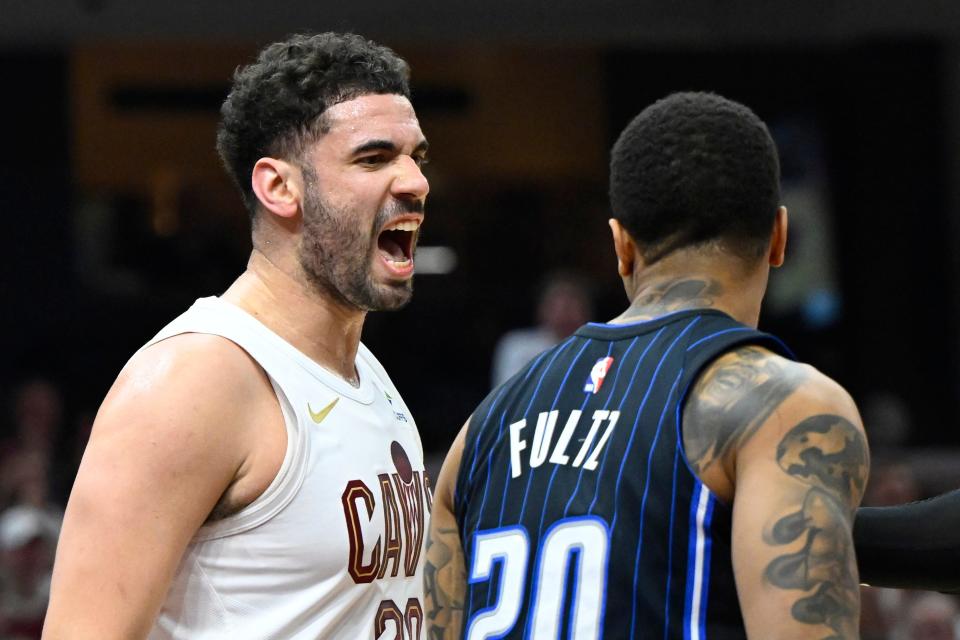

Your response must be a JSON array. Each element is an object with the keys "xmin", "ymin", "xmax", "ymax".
[{"xmin": 43, "ymin": 334, "xmax": 279, "ymax": 640}]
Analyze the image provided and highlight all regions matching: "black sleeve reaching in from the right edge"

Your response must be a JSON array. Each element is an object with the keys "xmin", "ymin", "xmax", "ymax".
[{"xmin": 853, "ymin": 490, "xmax": 960, "ymax": 592}]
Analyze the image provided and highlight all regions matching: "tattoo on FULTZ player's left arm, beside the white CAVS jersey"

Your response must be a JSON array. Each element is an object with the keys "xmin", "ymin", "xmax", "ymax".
[{"xmin": 423, "ymin": 527, "xmax": 466, "ymax": 640}]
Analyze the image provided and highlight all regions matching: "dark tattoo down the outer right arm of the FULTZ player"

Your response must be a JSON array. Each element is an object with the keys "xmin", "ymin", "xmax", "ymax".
[{"xmin": 764, "ymin": 415, "xmax": 869, "ymax": 639}]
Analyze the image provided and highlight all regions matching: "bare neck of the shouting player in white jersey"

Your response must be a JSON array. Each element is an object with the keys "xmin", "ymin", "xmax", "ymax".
[{"xmin": 222, "ymin": 249, "xmax": 366, "ymax": 385}]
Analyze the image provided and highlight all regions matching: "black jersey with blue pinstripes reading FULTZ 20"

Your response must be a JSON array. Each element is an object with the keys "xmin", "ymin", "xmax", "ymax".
[{"xmin": 454, "ymin": 309, "xmax": 789, "ymax": 640}]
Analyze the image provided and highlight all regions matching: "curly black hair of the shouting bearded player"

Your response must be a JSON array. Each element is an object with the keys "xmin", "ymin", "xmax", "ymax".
[{"xmin": 217, "ymin": 33, "xmax": 410, "ymax": 217}]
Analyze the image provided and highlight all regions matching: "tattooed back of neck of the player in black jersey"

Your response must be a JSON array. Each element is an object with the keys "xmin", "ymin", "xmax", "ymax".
[{"xmin": 613, "ymin": 251, "xmax": 768, "ymax": 327}]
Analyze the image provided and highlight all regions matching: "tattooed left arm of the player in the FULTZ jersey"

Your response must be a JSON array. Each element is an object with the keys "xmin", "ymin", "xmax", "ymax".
[{"xmin": 423, "ymin": 420, "xmax": 470, "ymax": 640}]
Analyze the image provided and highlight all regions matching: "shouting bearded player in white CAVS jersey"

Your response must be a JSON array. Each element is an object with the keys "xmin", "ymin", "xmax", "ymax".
[{"xmin": 44, "ymin": 33, "xmax": 431, "ymax": 640}]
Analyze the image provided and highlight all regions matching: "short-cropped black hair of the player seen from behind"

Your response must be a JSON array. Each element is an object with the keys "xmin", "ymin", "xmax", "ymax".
[{"xmin": 610, "ymin": 92, "xmax": 780, "ymax": 263}]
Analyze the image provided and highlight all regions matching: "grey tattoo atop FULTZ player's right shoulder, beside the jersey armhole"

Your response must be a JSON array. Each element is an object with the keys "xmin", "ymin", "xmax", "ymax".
[{"xmin": 684, "ymin": 347, "xmax": 805, "ymax": 473}]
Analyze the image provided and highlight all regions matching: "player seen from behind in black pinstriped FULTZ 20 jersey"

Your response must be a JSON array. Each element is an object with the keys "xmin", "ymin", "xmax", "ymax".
[{"xmin": 424, "ymin": 93, "xmax": 869, "ymax": 640}]
